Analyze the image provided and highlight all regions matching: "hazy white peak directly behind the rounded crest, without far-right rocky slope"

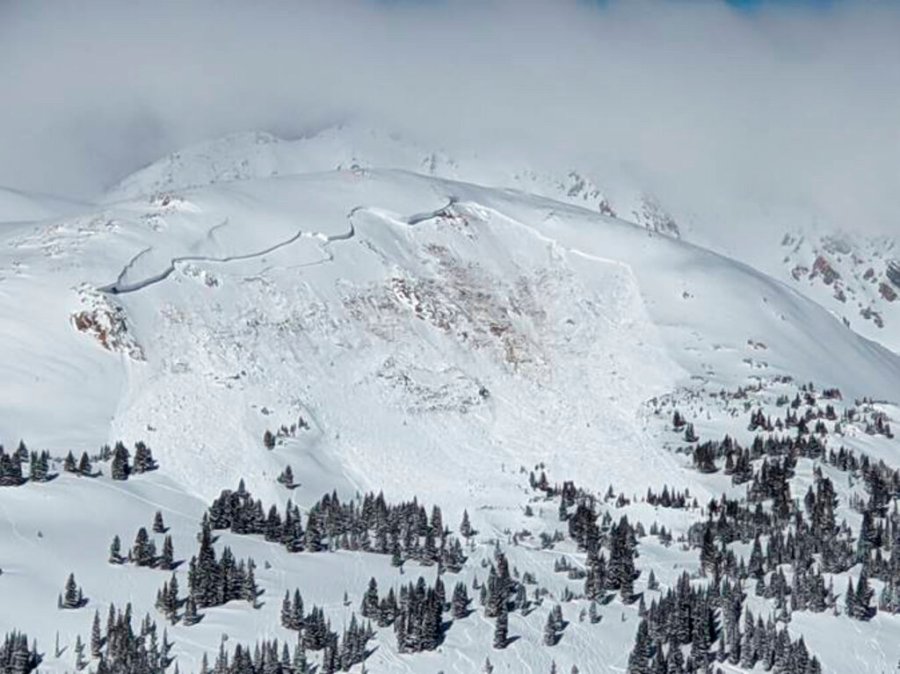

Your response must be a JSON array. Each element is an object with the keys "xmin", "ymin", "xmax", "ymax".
[{"xmin": 108, "ymin": 124, "xmax": 680, "ymax": 238}]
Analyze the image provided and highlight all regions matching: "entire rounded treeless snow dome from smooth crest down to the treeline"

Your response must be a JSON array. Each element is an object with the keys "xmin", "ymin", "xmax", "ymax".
[{"xmin": 5, "ymin": 168, "xmax": 900, "ymax": 498}]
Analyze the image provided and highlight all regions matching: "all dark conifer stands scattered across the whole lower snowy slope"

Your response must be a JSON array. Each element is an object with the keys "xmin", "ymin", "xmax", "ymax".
[{"xmin": 7, "ymin": 376, "xmax": 900, "ymax": 674}]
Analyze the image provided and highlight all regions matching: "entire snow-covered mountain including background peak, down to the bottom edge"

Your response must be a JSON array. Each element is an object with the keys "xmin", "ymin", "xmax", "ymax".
[{"xmin": 0, "ymin": 130, "xmax": 900, "ymax": 672}]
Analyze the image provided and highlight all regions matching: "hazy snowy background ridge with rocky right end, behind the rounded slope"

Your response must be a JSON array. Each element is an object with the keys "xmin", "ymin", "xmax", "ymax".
[{"xmin": 107, "ymin": 125, "xmax": 900, "ymax": 362}]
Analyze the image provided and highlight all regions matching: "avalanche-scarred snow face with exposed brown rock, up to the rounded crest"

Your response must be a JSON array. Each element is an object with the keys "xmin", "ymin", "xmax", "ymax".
[{"xmin": 29, "ymin": 171, "xmax": 681, "ymax": 498}]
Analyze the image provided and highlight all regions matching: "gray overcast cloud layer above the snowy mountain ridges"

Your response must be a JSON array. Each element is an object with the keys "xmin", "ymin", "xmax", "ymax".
[{"xmin": 0, "ymin": 0, "xmax": 900, "ymax": 231}]
